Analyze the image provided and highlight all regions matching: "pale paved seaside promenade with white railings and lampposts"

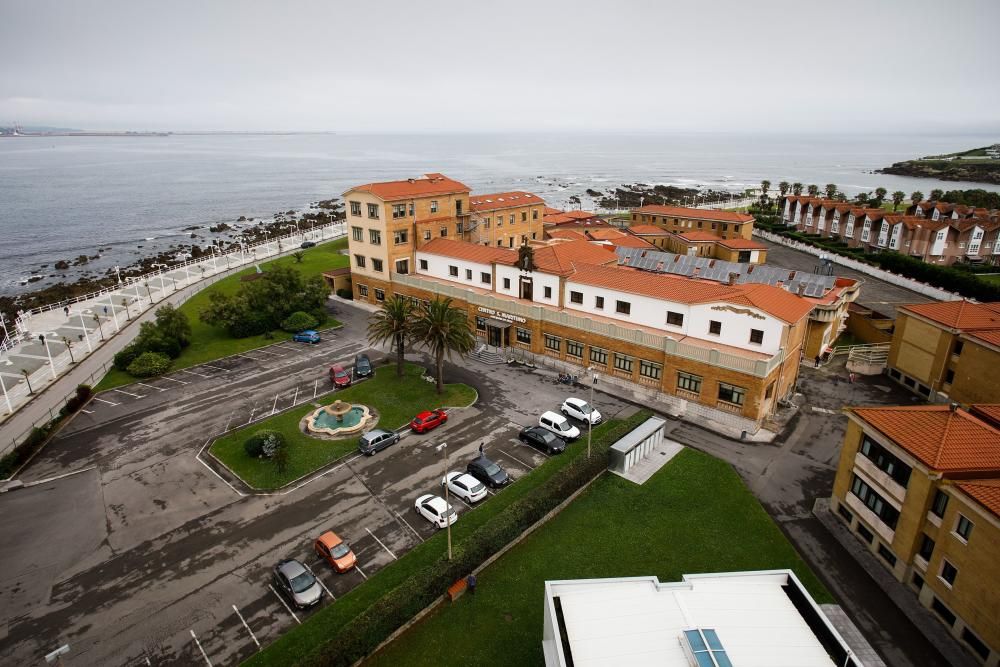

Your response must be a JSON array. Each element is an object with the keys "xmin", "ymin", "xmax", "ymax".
[{"xmin": 0, "ymin": 222, "xmax": 345, "ymax": 456}]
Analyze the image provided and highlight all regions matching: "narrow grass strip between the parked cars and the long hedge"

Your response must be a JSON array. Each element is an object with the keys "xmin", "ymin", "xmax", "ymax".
[{"xmin": 243, "ymin": 412, "xmax": 649, "ymax": 667}]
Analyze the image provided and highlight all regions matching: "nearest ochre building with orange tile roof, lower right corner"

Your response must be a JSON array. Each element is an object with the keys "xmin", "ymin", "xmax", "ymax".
[{"xmin": 831, "ymin": 403, "xmax": 1000, "ymax": 665}]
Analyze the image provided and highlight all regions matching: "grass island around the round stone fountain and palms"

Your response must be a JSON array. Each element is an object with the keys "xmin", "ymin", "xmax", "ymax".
[{"xmin": 209, "ymin": 364, "xmax": 476, "ymax": 489}]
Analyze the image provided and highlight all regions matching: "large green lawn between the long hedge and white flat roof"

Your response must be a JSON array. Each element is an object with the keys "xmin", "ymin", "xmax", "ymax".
[{"xmin": 366, "ymin": 449, "xmax": 832, "ymax": 665}]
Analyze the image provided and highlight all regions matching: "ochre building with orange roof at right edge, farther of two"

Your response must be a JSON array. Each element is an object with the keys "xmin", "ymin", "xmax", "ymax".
[{"xmin": 887, "ymin": 299, "xmax": 1000, "ymax": 405}]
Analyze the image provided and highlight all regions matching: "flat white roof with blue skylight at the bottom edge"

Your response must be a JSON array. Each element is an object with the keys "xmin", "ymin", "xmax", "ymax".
[{"xmin": 543, "ymin": 570, "xmax": 860, "ymax": 667}]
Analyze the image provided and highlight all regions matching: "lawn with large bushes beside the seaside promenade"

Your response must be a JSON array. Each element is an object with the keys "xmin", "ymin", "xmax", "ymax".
[{"xmin": 96, "ymin": 238, "xmax": 348, "ymax": 391}]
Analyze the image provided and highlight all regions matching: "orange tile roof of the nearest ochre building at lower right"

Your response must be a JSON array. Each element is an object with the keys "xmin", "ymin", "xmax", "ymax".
[{"xmin": 850, "ymin": 405, "xmax": 1000, "ymax": 472}]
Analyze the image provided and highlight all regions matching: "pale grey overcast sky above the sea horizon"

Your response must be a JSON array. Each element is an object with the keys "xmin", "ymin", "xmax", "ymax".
[{"xmin": 0, "ymin": 0, "xmax": 1000, "ymax": 132}]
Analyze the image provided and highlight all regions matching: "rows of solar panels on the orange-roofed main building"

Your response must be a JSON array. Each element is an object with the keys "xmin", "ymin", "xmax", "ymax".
[{"xmin": 617, "ymin": 247, "xmax": 837, "ymax": 297}]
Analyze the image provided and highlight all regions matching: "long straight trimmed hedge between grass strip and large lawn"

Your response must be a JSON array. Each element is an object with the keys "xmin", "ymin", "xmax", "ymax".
[{"xmin": 278, "ymin": 411, "xmax": 651, "ymax": 667}]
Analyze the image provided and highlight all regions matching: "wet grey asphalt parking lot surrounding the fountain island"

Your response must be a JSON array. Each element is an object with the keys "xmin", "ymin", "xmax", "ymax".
[{"xmin": 0, "ymin": 306, "xmax": 627, "ymax": 665}]
